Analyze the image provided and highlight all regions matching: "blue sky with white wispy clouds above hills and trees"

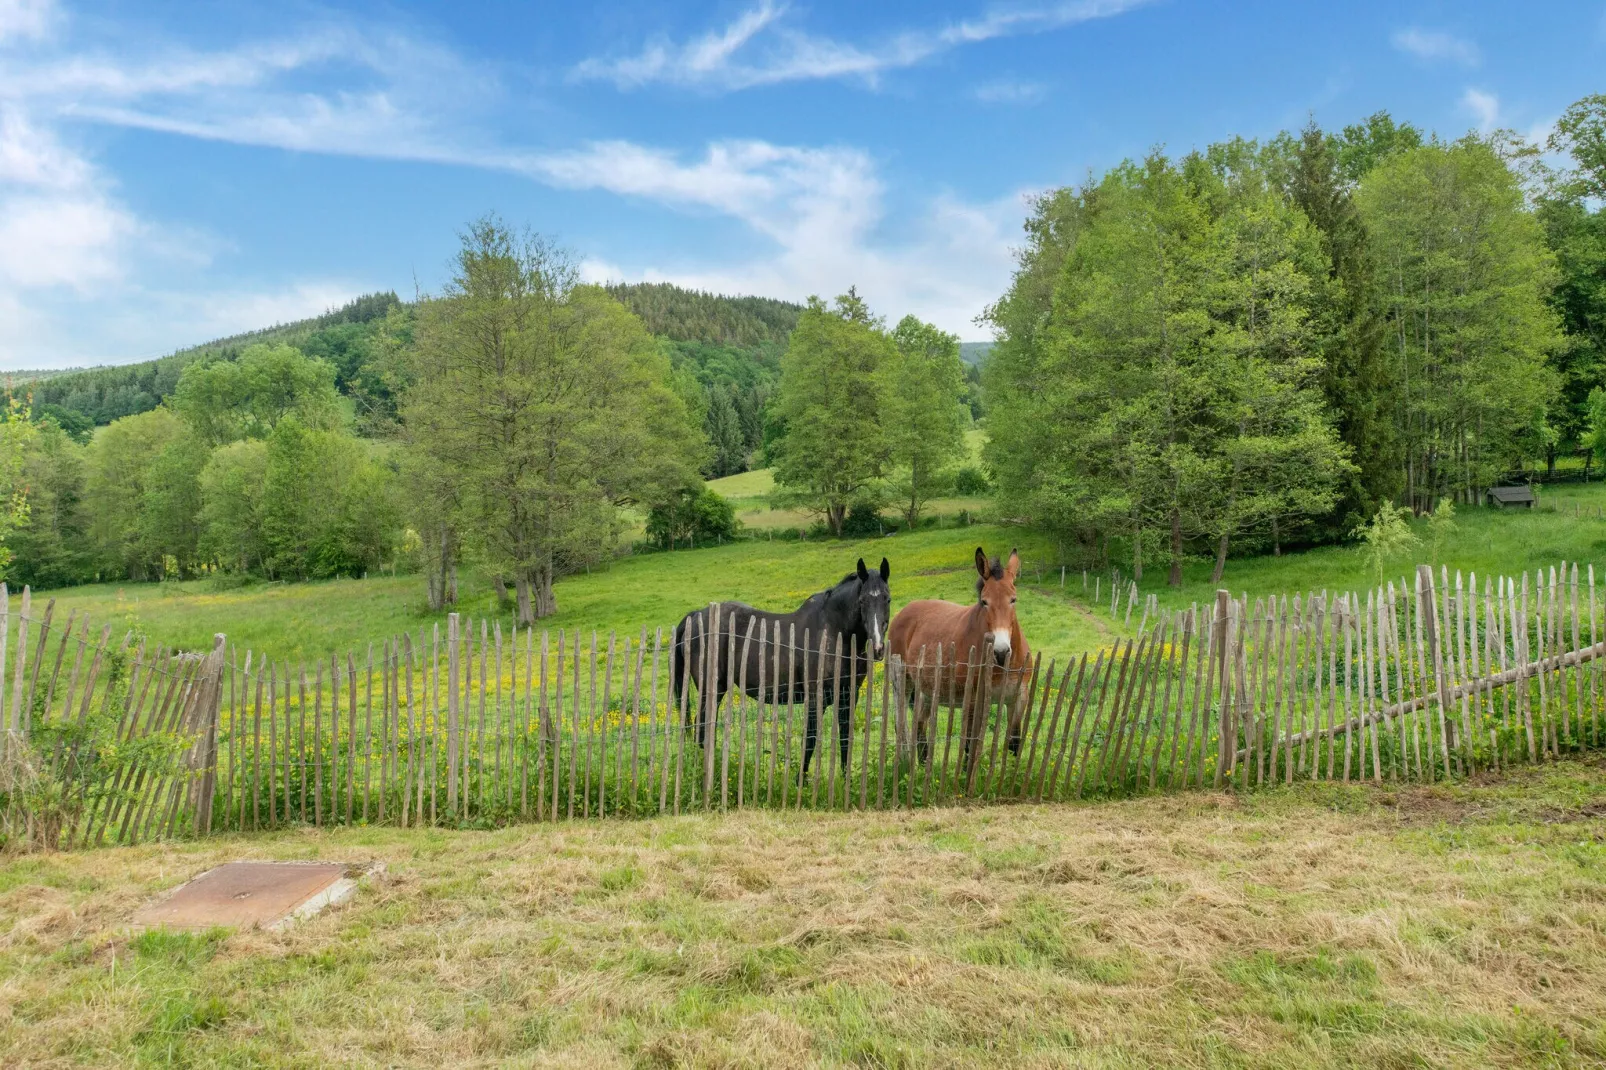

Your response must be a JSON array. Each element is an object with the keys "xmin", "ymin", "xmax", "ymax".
[{"xmin": 0, "ymin": 0, "xmax": 1606, "ymax": 371}]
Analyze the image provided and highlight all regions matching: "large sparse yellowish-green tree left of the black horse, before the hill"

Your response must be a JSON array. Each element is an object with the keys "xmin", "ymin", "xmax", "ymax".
[{"xmin": 402, "ymin": 218, "xmax": 700, "ymax": 623}]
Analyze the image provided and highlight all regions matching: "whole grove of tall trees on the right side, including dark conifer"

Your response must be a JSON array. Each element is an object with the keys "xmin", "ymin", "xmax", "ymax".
[{"xmin": 986, "ymin": 96, "xmax": 1606, "ymax": 583}]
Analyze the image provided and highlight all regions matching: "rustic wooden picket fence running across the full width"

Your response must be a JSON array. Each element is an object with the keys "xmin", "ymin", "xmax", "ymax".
[{"xmin": 0, "ymin": 564, "xmax": 1606, "ymax": 847}]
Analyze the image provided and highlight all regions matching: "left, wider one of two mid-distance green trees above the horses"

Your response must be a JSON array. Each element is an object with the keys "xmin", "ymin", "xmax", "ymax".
[{"xmin": 776, "ymin": 289, "xmax": 896, "ymax": 535}]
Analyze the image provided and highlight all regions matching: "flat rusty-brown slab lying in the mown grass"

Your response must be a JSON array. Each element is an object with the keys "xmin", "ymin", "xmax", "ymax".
[{"xmin": 133, "ymin": 863, "xmax": 380, "ymax": 929}]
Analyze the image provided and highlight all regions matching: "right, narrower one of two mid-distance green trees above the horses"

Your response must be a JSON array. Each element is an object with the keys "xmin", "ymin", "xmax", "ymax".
[{"xmin": 878, "ymin": 317, "xmax": 970, "ymax": 529}]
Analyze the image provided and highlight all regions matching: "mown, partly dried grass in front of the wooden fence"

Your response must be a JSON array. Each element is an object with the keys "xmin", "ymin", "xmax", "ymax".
[{"xmin": 0, "ymin": 763, "xmax": 1606, "ymax": 1067}]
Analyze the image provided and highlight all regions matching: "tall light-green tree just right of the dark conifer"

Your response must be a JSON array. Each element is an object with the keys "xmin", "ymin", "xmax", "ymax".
[{"xmin": 1357, "ymin": 137, "xmax": 1561, "ymax": 513}]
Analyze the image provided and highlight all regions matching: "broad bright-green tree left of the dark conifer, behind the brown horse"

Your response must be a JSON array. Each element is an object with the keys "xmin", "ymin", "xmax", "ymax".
[{"xmin": 989, "ymin": 145, "xmax": 1346, "ymax": 583}]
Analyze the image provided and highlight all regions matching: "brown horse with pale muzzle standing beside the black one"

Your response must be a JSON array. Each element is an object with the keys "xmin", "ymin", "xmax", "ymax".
[{"xmin": 887, "ymin": 546, "xmax": 1031, "ymax": 773}]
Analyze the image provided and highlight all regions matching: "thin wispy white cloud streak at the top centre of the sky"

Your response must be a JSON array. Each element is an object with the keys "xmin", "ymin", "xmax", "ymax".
[{"xmin": 570, "ymin": 0, "xmax": 1147, "ymax": 90}]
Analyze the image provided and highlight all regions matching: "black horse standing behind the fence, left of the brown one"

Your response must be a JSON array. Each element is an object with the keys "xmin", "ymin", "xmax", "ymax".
[{"xmin": 673, "ymin": 557, "xmax": 891, "ymax": 774}]
